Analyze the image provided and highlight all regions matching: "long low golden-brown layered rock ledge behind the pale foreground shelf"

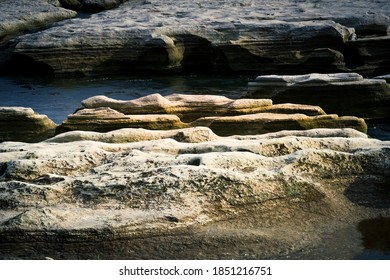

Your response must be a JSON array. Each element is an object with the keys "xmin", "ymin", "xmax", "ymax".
[{"xmin": 58, "ymin": 94, "xmax": 367, "ymax": 136}]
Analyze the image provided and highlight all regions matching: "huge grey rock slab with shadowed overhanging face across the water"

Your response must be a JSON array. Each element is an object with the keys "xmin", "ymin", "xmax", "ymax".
[{"xmin": 3, "ymin": 1, "xmax": 362, "ymax": 75}]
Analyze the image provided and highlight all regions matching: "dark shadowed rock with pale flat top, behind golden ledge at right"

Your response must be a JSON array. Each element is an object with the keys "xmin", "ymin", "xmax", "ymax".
[{"xmin": 244, "ymin": 73, "xmax": 390, "ymax": 119}]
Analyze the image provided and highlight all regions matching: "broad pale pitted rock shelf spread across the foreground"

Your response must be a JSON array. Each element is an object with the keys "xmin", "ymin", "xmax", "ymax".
[{"xmin": 0, "ymin": 130, "xmax": 390, "ymax": 258}]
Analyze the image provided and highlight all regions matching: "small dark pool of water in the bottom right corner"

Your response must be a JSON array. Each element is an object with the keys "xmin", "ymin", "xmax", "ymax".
[{"xmin": 356, "ymin": 217, "xmax": 390, "ymax": 260}]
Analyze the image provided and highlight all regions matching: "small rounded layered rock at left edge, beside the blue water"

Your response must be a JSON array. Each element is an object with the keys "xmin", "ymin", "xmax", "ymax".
[{"xmin": 0, "ymin": 107, "xmax": 57, "ymax": 142}]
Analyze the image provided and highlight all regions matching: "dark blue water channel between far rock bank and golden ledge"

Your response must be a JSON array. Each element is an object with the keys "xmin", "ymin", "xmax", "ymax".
[{"xmin": 0, "ymin": 76, "xmax": 250, "ymax": 124}]
